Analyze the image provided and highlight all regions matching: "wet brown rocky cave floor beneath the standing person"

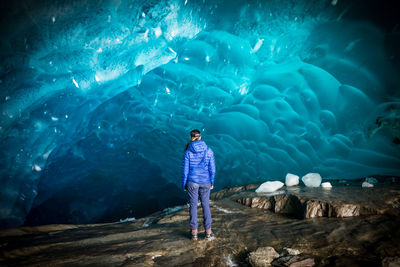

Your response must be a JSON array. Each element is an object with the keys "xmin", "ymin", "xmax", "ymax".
[{"xmin": 0, "ymin": 184, "xmax": 400, "ymax": 266}]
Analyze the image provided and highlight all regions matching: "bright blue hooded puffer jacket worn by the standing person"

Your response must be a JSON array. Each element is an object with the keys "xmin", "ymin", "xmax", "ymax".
[{"xmin": 182, "ymin": 140, "xmax": 215, "ymax": 189}]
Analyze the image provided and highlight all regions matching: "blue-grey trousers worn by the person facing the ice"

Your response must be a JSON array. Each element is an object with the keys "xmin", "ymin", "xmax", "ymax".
[{"xmin": 186, "ymin": 182, "xmax": 212, "ymax": 230}]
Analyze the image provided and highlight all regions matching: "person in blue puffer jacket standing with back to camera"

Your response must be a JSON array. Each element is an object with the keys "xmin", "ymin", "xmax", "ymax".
[{"xmin": 182, "ymin": 129, "xmax": 215, "ymax": 240}]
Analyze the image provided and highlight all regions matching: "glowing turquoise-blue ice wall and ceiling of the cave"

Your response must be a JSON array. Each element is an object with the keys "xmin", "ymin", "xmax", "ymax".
[{"xmin": 0, "ymin": 0, "xmax": 400, "ymax": 226}]
